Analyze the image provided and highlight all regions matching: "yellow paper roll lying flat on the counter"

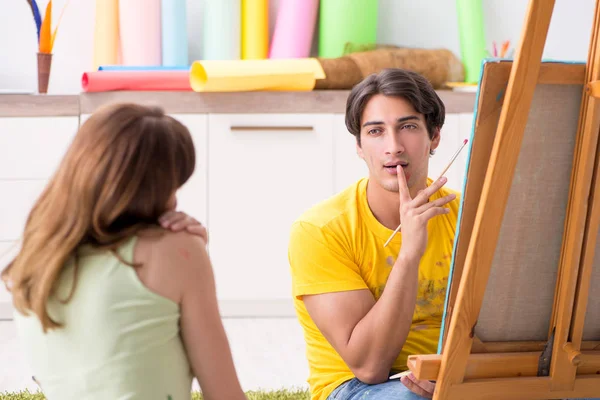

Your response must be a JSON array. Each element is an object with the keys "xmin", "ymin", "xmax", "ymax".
[{"xmin": 190, "ymin": 58, "xmax": 325, "ymax": 92}]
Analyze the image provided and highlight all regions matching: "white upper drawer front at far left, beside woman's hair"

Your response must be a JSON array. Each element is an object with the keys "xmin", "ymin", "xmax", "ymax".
[{"xmin": 0, "ymin": 116, "xmax": 79, "ymax": 180}]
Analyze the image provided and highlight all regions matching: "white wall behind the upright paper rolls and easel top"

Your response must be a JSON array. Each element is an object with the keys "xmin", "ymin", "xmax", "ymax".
[{"xmin": 0, "ymin": 0, "xmax": 594, "ymax": 93}]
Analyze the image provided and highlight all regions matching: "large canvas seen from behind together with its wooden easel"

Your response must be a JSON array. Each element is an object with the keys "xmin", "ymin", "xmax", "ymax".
[{"xmin": 408, "ymin": 0, "xmax": 600, "ymax": 399}]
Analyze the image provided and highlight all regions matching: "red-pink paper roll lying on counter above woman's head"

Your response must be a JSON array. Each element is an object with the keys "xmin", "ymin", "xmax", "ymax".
[{"xmin": 81, "ymin": 71, "xmax": 192, "ymax": 92}]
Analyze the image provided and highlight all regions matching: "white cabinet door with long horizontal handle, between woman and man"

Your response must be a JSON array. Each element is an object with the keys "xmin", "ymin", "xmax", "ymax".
[{"xmin": 208, "ymin": 114, "xmax": 333, "ymax": 300}]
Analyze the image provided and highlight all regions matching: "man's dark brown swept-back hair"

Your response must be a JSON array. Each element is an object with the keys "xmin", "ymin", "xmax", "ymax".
[{"xmin": 346, "ymin": 68, "xmax": 446, "ymax": 152}]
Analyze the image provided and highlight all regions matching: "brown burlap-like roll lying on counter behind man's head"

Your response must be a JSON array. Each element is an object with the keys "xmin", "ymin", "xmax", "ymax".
[{"xmin": 315, "ymin": 48, "xmax": 464, "ymax": 89}]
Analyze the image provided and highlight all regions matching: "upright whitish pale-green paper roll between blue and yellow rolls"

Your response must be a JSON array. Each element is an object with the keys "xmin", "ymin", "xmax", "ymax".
[{"xmin": 202, "ymin": 0, "xmax": 241, "ymax": 60}]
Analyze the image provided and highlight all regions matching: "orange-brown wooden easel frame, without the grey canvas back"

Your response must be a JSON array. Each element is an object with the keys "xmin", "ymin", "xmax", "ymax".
[{"xmin": 408, "ymin": 0, "xmax": 600, "ymax": 400}]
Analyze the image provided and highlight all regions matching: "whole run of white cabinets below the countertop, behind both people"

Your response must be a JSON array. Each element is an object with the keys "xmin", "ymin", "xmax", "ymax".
[{"xmin": 0, "ymin": 109, "xmax": 473, "ymax": 319}]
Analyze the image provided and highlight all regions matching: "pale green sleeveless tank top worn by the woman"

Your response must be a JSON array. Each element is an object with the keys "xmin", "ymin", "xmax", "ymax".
[{"xmin": 15, "ymin": 237, "xmax": 192, "ymax": 400}]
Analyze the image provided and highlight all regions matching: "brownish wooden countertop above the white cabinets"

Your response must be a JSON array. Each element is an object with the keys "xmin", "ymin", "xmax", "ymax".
[{"xmin": 0, "ymin": 90, "xmax": 475, "ymax": 117}]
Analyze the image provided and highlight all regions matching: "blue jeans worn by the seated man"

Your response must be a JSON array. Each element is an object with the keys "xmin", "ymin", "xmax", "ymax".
[{"xmin": 327, "ymin": 378, "xmax": 599, "ymax": 400}]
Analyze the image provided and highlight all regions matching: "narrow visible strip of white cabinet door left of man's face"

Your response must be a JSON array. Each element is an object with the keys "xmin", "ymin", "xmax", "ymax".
[{"xmin": 333, "ymin": 114, "xmax": 369, "ymax": 193}]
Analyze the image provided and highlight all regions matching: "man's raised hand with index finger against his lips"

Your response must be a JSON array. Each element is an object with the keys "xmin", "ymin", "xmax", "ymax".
[{"xmin": 396, "ymin": 166, "xmax": 456, "ymax": 259}]
